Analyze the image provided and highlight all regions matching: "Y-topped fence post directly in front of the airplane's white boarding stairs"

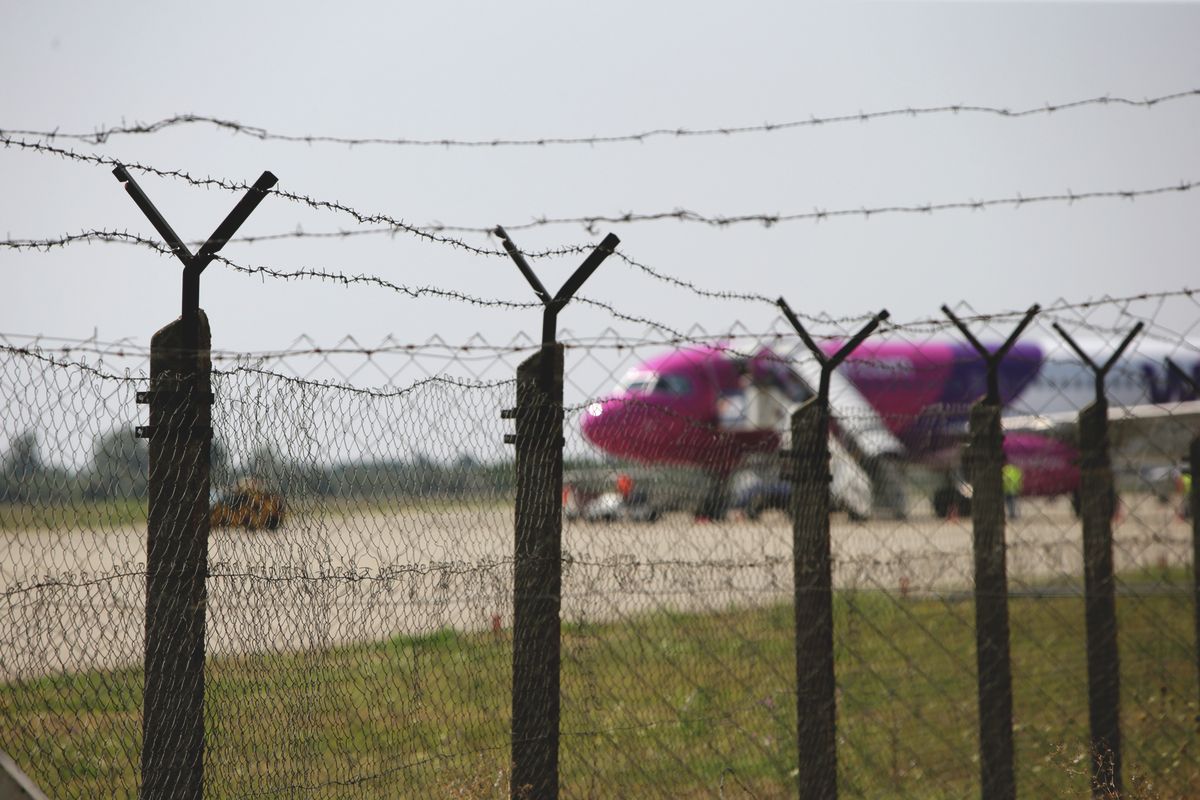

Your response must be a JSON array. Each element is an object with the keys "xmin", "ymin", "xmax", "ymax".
[{"xmin": 776, "ymin": 297, "xmax": 888, "ymax": 800}]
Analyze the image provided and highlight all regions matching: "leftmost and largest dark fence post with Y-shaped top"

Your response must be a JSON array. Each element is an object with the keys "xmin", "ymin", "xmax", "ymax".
[{"xmin": 113, "ymin": 167, "xmax": 276, "ymax": 800}]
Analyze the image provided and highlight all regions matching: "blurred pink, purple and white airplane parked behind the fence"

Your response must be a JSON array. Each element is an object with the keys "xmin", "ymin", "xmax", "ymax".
[{"xmin": 581, "ymin": 341, "xmax": 1200, "ymax": 518}]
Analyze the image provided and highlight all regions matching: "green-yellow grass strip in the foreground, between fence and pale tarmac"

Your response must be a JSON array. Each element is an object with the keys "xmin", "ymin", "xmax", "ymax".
[{"xmin": 0, "ymin": 571, "xmax": 1200, "ymax": 799}]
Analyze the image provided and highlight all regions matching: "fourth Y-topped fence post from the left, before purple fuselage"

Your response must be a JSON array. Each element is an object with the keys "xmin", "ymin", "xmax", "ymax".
[{"xmin": 942, "ymin": 306, "xmax": 1039, "ymax": 800}]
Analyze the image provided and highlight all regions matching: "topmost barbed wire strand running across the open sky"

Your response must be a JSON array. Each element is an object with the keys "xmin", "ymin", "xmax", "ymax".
[{"xmin": 0, "ymin": 89, "xmax": 1200, "ymax": 148}]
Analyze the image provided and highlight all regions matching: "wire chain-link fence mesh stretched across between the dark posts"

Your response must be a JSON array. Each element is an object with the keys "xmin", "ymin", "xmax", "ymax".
[{"xmin": 0, "ymin": 300, "xmax": 1200, "ymax": 798}]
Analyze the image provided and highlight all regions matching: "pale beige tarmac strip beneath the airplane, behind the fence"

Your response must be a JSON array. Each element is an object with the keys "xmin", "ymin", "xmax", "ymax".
[{"xmin": 0, "ymin": 498, "xmax": 1192, "ymax": 681}]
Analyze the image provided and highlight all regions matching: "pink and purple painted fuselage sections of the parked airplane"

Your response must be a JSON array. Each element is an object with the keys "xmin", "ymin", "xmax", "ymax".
[{"xmin": 582, "ymin": 342, "xmax": 1079, "ymax": 495}]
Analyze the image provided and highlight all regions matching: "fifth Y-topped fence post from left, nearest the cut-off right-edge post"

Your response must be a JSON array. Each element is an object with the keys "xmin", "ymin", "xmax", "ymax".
[{"xmin": 1054, "ymin": 323, "xmax": 1142, "ymax": 798}]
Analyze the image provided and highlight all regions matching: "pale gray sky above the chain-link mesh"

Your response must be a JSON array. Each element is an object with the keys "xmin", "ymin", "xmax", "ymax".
[{"xmin": 0, "ymin": 2, "xmax": 1200, "ymax": 364}]
